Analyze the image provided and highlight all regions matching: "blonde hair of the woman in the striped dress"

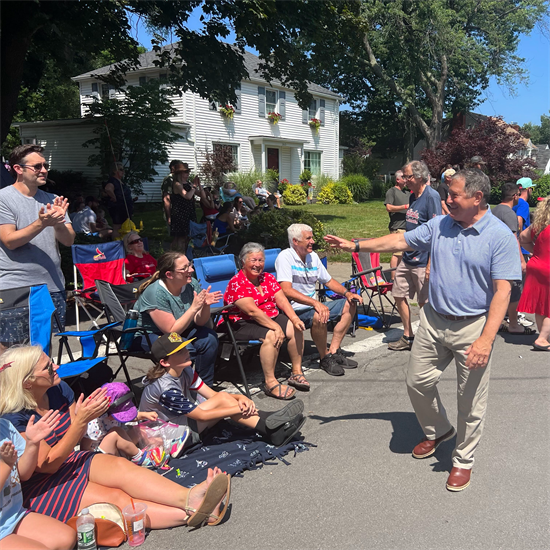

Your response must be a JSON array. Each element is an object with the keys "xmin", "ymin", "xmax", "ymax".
[{"xmin": 0, "ymin": 345, "xmax": 43, "ymax": 415}]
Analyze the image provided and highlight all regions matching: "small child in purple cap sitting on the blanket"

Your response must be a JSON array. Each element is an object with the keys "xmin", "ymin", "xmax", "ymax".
[{"xmin": 80, "ymin": 382, "xmax": 189, "ymax": 468}]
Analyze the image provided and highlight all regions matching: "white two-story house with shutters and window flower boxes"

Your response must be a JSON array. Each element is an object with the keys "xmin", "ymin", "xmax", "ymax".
[{"xmin": 19, "ymin": 46, "xmax": 341, "ymax": 200}]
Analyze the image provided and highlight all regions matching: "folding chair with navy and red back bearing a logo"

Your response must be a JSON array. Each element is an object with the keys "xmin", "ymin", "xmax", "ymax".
[{"xmin": 71, "ymin": 241, "xmax": 126, "ymax": 330}]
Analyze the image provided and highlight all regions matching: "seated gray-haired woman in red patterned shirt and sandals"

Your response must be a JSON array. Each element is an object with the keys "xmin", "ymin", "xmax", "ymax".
[{"xmin": 223, "ymin": 243, "xmax": 309, "ymax": 400}]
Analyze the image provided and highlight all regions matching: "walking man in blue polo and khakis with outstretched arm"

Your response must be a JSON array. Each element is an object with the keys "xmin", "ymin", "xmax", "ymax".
[{"xmin": 325, "ymin": 169, "xmax": 521, "ymax": 491}]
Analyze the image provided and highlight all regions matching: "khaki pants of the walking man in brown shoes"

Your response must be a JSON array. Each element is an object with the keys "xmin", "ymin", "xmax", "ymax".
[{"xmin": 407, "ymin": 304, "xmax": 492, "ymax": 468}]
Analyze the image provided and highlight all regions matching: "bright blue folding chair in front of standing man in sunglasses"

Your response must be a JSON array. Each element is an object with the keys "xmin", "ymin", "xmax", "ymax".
[{"xmin": 0, "ymin": 285, "xmax": 121, "ymax": 396}]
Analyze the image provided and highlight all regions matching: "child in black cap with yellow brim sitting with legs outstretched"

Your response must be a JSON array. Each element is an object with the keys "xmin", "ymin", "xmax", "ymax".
[{"xmin": 139, "ymin": 332, "xmax": 306, "ymax": 446}]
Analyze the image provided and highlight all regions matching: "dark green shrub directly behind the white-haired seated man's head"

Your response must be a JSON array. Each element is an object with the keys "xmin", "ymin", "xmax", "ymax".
[{"xmin": 238, "ymin": 208, "xmax": 328, "ymax": 250}]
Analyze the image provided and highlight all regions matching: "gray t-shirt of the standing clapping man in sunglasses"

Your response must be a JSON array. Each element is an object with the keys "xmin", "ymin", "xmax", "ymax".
[{"xmin": 0, "ymin": 185, "xmax": 71, "ymax": 292}]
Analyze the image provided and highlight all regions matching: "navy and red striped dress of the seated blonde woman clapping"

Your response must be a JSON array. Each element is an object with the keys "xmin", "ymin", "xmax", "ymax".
[{"xmin": 2, "ymin": 382, "xmax": 94, "ymax": 522}]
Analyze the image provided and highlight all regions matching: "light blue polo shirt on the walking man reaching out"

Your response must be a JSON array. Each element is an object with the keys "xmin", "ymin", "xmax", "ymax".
[{"xmin": 404, "ymin": 209, "xmax": 521, "ymax": 316}]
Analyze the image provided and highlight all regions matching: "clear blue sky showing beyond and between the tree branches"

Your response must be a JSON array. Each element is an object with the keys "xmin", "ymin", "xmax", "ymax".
[{"xmin": 130, "ymin": 15, "xmax": 550, "ymax": 125}]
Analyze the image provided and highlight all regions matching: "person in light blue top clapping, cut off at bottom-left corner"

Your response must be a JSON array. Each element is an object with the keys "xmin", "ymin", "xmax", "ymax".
[{"xmin": 0, "ymin": 414, "xmax": 76, "ymax": 550}]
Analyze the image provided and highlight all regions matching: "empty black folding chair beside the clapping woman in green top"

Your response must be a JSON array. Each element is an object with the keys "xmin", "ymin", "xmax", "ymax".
[{"xmin": 95, "ymin": 279, "xmax": 155, "ymax": 393}]
